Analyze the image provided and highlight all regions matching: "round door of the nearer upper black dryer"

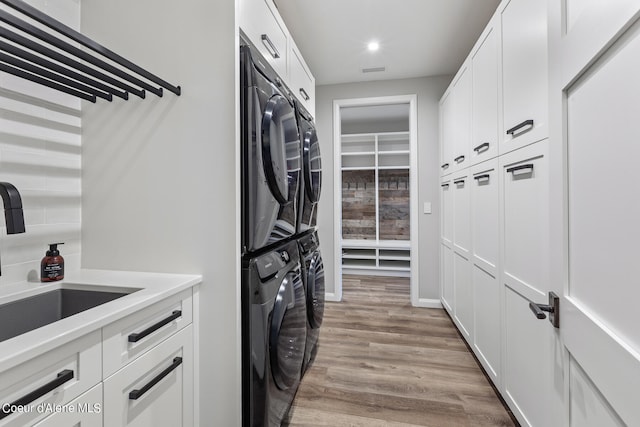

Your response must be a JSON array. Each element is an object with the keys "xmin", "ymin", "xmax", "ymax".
[{"xmin": 262, "ymin": 95, "xmax": 299, "ymax": 205}]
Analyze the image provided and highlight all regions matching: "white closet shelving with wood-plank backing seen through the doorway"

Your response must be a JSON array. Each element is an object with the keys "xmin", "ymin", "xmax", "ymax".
[{"xmin": 341, "ymin": 132, "xmax": 411, "ymax": 276}]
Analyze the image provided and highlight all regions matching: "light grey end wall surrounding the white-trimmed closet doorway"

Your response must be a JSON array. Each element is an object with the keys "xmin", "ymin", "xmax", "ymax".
[{"xmin": 316, "ymin": 76, "xmax": 451, "ymax": 299}]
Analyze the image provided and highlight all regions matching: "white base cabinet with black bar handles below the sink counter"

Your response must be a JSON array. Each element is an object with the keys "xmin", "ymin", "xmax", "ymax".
[{"xmin": 0, "ymin": 289, "xmax": 194, "ymax": 427}]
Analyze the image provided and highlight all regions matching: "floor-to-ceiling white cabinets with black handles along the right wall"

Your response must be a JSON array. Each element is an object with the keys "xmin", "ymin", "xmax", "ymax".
[{"xmin": 440, "ymin": 0, "xmax": 558, "ymax": 426}]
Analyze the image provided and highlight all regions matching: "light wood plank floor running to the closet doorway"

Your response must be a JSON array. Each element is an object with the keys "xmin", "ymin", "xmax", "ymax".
[{"xmin": 284, "ymin": 276, "xmax": 517, "ymax": 427}]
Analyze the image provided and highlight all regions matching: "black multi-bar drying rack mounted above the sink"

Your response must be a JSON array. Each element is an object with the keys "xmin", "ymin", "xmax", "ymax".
[{"xmin": 0, "ymin": 0, "xmax": 181, "ymax": 102}]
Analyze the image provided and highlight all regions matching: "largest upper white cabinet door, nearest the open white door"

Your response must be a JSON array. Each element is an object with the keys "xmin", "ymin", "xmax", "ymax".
[{"xmin": 499, "ymin": 0, "xmax": 549, "ymax": 153}]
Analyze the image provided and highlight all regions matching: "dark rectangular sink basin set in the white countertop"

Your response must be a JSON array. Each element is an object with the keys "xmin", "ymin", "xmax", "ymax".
[{"xmin": 0, "ymin": 287, "xmax": 138, "ymax": 342}]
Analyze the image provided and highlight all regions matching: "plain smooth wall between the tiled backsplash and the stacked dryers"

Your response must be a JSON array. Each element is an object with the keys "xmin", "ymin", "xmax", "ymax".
[{"xmin": 82, "ymin": 0, "xmax": 241, "ymax": 426}]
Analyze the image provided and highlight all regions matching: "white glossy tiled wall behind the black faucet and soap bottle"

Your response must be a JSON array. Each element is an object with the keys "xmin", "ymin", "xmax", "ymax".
[{"xmin": 0, "ymin": 0, "xmax": 81, "ymax": 286}]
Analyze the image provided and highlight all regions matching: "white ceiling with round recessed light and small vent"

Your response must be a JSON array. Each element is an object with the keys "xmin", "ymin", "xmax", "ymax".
[{"xmin": 275, "ymin": 0, "xmax": 500, "ymax": 85}]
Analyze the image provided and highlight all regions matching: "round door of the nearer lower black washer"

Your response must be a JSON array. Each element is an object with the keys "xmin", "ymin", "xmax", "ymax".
[{"xmin": 269, "ymin": 272, "xmax": 307, "ymax": 390}]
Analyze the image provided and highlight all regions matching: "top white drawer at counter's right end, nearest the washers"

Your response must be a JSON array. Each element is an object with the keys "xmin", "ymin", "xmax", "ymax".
[{"xmin": 102, "ymin": 289, "xmax": 193, "ymax": 378}]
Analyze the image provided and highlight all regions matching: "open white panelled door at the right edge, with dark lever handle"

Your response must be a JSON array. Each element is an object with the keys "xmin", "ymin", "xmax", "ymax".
[{"xmin": 549, "ymin": 0, "xmax": 640, "ymax": 427}]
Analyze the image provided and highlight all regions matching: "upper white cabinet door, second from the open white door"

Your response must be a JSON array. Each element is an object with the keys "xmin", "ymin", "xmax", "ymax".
[{"xmin": 469, "ymin": 19, "xmax": 500, "ymax": 164}]
